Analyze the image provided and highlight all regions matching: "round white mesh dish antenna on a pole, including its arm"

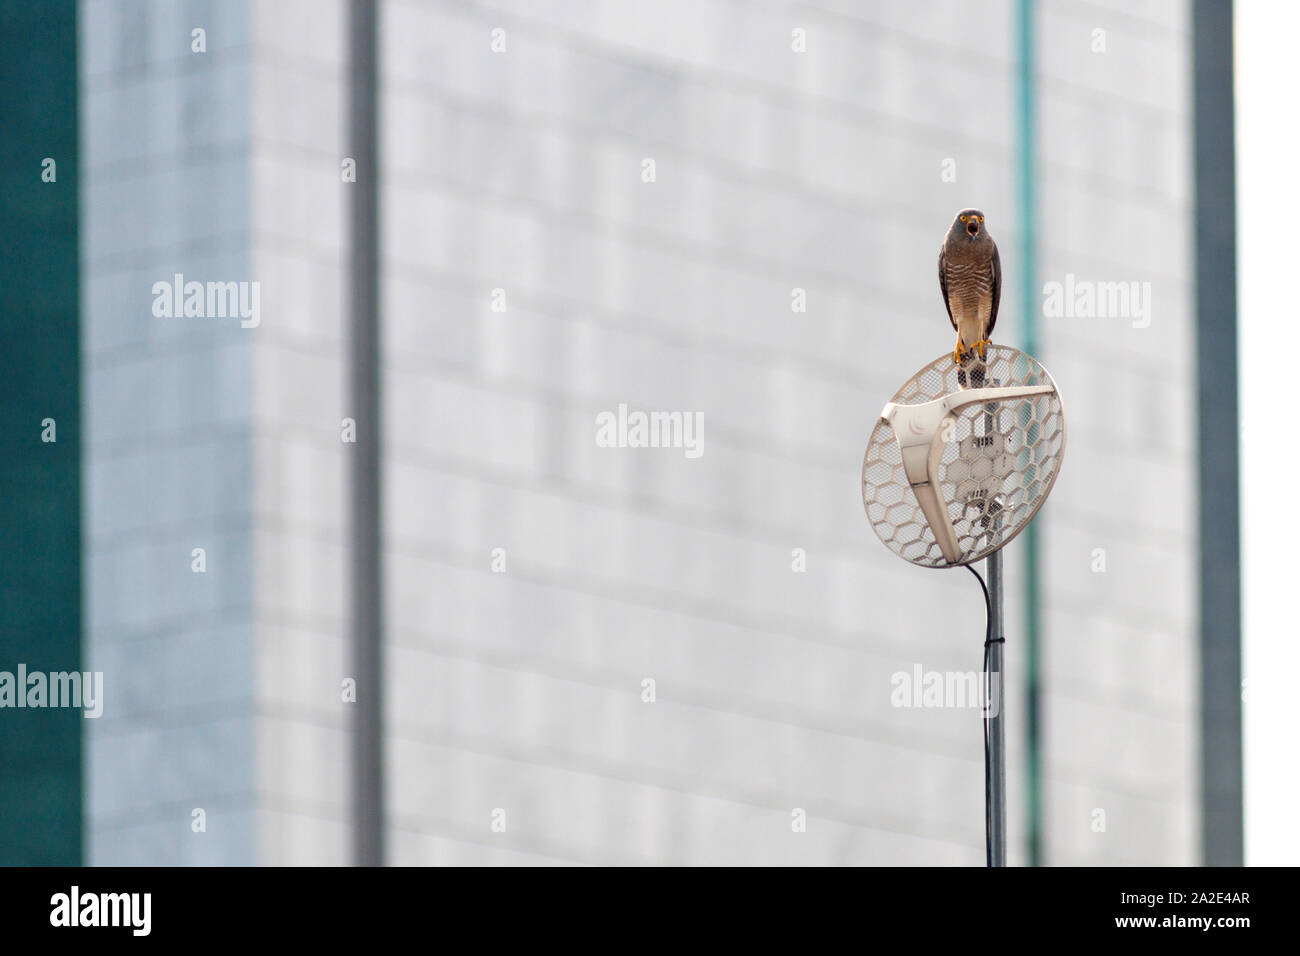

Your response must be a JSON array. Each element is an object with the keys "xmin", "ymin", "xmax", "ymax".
[{"xmin": 862, "ymin": 345, "xmax": 1065, "ymax": 567}]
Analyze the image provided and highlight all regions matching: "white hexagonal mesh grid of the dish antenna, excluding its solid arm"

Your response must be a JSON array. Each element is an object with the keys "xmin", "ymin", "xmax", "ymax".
[{"xmin": 862, "ymin": 345, "xmax": 1065, "ymax": 567}]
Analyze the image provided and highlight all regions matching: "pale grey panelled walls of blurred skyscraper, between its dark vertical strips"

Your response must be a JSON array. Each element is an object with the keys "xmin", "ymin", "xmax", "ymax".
[{"xmin": 58, "ymin": 0, "xmax": 1216, "ymax": 865}]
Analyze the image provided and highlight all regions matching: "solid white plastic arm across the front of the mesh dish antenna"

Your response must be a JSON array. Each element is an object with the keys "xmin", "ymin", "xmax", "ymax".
[{"xmin": 880, "ymin": 385, "xmax": 1056, "ymax": 564}]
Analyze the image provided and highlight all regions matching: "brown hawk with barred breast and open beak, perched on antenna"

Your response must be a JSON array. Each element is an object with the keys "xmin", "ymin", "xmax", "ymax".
[{"xmin": 939, "ymin": 209, "xmax": 1002, "ymax": 365}]
